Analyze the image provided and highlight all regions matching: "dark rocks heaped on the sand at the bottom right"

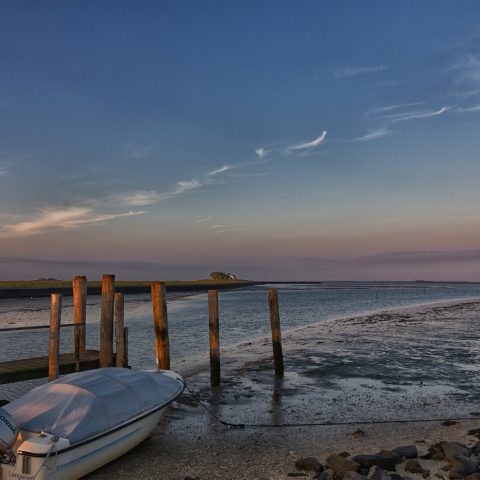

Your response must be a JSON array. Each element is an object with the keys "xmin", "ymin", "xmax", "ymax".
[{"xmin": 288, "ymin": 436, "xmax": 480, "ymax": 480}]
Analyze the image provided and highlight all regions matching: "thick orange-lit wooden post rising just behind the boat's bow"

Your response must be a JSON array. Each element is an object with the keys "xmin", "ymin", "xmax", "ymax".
[{"xmin": 152, "ymin": 282, "xmax": 170, "ymax": 370}]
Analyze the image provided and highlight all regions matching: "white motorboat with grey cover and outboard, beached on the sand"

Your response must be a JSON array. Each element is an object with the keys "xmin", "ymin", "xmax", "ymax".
[{"xmin": 0, "ymin": 368, "xmax": 184, "ymax": 480}]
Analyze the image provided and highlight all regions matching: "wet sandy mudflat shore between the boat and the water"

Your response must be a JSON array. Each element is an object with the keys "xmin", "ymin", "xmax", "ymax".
[{"xmin": 81, "ymin": 299, "xmax": 480, "ymax": 480}]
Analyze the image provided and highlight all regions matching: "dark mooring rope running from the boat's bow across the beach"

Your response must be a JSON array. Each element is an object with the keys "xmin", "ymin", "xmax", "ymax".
[{"xmin": 183, "ymin": 380, "xmax": 475, "ymax": 428}]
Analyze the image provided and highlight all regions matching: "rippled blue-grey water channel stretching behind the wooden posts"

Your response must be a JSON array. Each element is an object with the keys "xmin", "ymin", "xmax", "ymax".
[{"xmin": 0, "ymin": 283, "xmax": 480, "ymax": 374}]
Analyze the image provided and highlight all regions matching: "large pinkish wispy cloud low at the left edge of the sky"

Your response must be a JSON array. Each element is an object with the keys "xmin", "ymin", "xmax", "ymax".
[{"xmin": 0, "ymin": 207, "xmax": 144, "ymax": 237}]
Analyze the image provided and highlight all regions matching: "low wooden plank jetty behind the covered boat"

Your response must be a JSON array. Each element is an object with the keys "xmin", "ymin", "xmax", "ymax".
[{"xmin": 0, "ymin": 350, "xmax": 104, "ymax": 384}]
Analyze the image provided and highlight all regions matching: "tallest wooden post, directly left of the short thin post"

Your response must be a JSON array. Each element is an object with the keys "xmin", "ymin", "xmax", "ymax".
[{"xmin": 100, "ymin": 275, "xmax": 115, "ymax": 367}]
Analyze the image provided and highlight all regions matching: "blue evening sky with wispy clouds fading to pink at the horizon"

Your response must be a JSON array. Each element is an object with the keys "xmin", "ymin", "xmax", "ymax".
[{"xmin": 0, "ymin": 1, "xmax": 480, "ymax": 281}]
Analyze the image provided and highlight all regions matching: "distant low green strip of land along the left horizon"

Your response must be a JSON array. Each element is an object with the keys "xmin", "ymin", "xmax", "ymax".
[{"xmin": 0, "ymin": 280, "xmax": 256, "ymax": 299}]
